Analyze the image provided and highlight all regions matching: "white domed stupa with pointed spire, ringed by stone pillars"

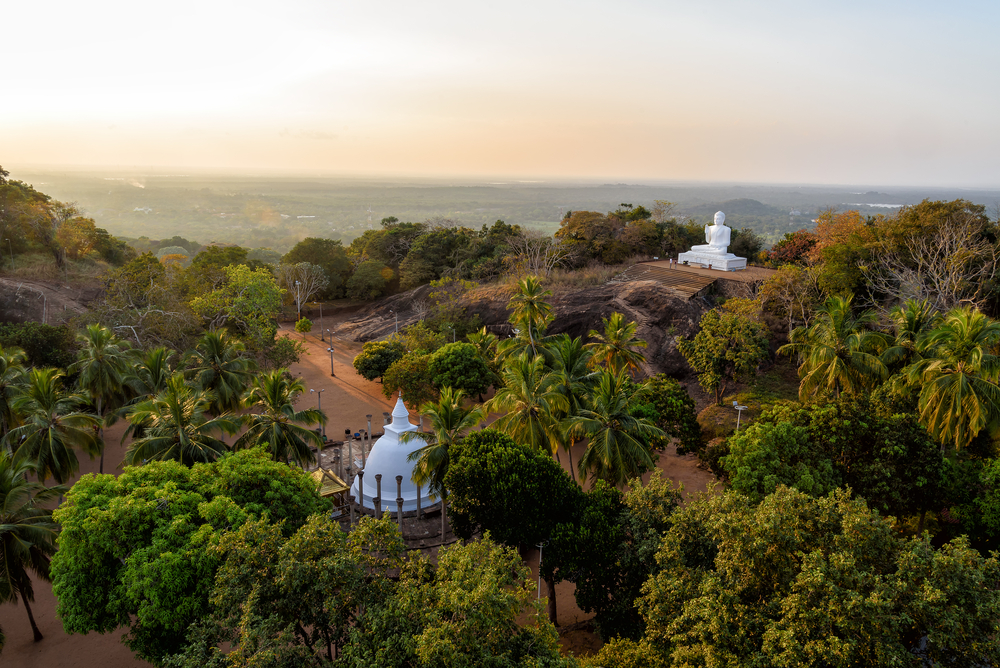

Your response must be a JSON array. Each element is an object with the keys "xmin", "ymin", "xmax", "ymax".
[{"xmin": 351, "ymin": 398, "xmax": 432, "ymax": 513}]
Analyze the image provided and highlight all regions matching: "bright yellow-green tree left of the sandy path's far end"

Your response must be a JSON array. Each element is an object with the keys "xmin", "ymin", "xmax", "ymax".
[{"xmin": 191, "ymin": 265, "xmax": 283, "ymax": 348}]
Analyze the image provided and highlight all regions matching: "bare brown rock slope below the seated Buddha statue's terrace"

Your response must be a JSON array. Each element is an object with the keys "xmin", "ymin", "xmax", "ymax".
[{"xmin": 337, "ymin": 281, "xmax": 708, "ymax": 377}]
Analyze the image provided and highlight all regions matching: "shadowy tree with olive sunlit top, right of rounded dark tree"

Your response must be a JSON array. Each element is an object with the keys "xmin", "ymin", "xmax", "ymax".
[{"xmin": 543, "ymin": 471, "xmax": 681, "ymax": 642}]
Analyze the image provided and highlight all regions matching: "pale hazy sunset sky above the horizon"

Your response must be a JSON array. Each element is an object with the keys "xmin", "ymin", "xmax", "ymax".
[{"xmin": 0, "ymin": 0, "xmax": 1000, "ymax": 187}]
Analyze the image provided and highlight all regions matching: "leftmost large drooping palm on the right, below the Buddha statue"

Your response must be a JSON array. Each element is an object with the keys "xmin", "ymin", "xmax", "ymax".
[{"xmin": 778, "ymin": 296, "xmax": 887, "ymax": 401}]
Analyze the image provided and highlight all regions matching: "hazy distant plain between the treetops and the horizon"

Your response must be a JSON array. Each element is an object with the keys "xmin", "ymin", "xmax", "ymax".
[{"xmin": 17, "ymin": 171, "xmax": 1000, "ymax": 251}]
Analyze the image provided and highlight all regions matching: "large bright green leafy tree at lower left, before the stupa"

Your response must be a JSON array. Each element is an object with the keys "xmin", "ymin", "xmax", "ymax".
[{"xmin": 52, "ymin": 450, "xmax": 330, "ymax": 663}]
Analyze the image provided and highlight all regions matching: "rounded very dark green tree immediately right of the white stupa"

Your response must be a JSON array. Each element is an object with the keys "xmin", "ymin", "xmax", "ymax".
[{"xmin": 444, "ymin": 429, "xmax": 580, "ymax": 623}]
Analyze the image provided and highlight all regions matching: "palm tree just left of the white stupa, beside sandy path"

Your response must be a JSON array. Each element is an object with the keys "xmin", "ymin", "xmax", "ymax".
[{"xmin": 233, "ymin": 369, "xmax": 326, "ymax": 467}]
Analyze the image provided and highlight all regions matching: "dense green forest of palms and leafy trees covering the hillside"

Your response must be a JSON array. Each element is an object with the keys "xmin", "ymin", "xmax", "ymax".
[{"xmin": 0, "ymin": 163, "xmax": 1000, "ymax": 668}]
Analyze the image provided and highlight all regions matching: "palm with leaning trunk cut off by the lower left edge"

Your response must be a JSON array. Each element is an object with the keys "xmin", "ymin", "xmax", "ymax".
[{"xmin": 0, "ymin": 450, "xmax": 66, "ymax": 642}]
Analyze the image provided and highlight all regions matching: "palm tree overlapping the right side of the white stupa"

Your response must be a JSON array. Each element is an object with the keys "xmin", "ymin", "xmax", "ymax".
[{"xmin": 400, "ymin": 387, "xmax": 486, "ymax": 499}]
